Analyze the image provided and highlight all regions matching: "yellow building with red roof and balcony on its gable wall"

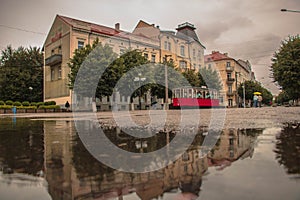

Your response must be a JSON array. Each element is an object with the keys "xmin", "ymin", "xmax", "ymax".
[{"xmin": 44, "ymin": 15, "xmax": 160, "ymax": 106}]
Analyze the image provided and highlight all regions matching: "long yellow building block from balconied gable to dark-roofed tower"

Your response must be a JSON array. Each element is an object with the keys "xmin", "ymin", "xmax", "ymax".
[{"xmin": 43, "ymin": 15, "xmax": 205, "ymax": 106}]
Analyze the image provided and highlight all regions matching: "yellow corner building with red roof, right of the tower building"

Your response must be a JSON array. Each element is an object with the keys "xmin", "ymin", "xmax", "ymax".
[{"xmin": 204, "ymin": 51, "xmax": 255, "ymax": 107}]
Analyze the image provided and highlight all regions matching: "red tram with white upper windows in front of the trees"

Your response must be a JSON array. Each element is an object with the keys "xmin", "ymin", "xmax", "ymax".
[{"xmin": 171, "ymin": 86, "xmax": 220, "ymax": 109}]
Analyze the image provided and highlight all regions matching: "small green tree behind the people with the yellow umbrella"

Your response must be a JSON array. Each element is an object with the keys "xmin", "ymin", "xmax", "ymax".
[{"xmin": 238, "ymin": 81, "xmax": 273, "ymax": 104}]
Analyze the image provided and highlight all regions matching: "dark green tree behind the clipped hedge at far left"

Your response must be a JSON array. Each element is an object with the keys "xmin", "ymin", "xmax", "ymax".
[{"xmin": 0, "ymin": 46, "xmax": 44, "ymax": 102}]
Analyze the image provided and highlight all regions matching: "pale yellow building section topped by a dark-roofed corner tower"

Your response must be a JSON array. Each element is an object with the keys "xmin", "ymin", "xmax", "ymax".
[{"xmin": 133, "ymin": 20, "xmax": 205, "ymax": 71}]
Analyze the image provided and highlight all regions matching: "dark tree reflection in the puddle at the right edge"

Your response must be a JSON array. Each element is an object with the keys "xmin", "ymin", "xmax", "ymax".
[{"xmin": 274, "ymin": 123, "xmax": 300, "ymax": 174}]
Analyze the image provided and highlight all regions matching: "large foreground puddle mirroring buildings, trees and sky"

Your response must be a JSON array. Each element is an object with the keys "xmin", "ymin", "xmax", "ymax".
[{"xmin": 0, "ymin": 118, "xmax": 300, "ymax": 199}]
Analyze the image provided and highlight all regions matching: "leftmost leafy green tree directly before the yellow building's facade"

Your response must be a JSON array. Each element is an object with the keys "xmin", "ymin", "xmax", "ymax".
[{"xmin": 68, "ymin": 39, "xmax": 117, "ymax": 97}]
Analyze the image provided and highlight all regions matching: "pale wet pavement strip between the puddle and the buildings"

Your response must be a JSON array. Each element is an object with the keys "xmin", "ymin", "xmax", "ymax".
[{"xmin": 0, "ymin": 107, "xmax": 300, "ymax": 128}]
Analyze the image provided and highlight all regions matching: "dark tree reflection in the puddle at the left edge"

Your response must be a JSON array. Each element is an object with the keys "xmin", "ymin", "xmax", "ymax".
[{"xmin": 0, "ymin": 118, "xmax": 44, "ymax": 175}]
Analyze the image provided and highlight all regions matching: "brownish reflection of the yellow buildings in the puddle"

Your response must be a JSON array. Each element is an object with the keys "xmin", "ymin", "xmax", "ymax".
[{"xmin": 44, "ymin": 121, "xmax": 261, "ymax": 200}]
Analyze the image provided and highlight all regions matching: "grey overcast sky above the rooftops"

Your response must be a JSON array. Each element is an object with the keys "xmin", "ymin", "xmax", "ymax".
[{"xmin": 0, "ymin": 0, "xmax": 300, "ymax": 92}]
